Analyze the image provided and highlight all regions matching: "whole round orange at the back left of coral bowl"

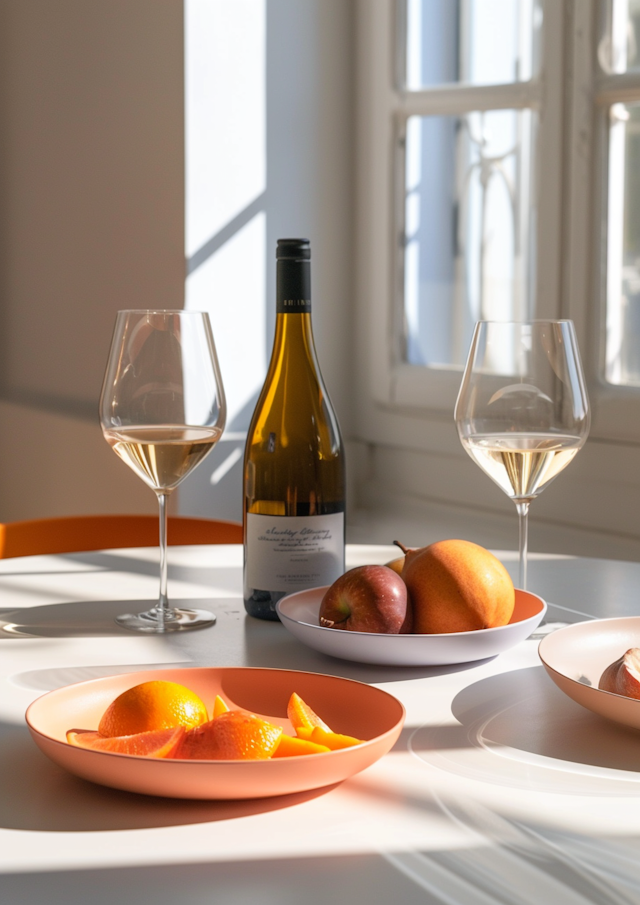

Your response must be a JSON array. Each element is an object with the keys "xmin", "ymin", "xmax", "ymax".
[{"xmin": 98, "ymin": 680, "xmax": 209, "ymax": 738}]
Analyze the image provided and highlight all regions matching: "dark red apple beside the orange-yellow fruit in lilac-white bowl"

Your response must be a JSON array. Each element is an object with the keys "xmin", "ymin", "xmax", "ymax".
[{"xmin": 319, "ymin": 566, "xmax": 413, "ymax": 635}]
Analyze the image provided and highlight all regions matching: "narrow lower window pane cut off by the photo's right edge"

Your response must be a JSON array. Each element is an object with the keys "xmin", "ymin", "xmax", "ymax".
[{"xmin": 606, "ymin": 103, "xmax": 640, "ymax": 386}]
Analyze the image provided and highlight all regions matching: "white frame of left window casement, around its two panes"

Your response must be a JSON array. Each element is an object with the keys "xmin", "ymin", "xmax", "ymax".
[{"xmin": 358, "ymin": 0, "xmax": 564, "ymax": 415}]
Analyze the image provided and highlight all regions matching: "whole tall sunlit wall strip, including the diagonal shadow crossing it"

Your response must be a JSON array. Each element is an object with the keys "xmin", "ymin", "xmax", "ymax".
[{"xmin": 185, "ymin": 0, "xmax": 266, "ymax": 431}]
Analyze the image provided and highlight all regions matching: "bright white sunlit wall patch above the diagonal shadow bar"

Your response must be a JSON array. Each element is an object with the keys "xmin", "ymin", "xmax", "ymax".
[{"xmin": 185, "ymin": 0, "xmax": 266, "ymax": 258}]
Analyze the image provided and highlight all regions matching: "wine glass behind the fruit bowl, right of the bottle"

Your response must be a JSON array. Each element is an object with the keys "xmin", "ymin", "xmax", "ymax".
[{"xmin": 454, "ymin": 320, "xmax": 589, "ymax": 590}]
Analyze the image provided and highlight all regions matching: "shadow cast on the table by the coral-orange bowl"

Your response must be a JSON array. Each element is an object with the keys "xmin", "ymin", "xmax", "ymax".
[{"xmin": 0, "ymin": 723, "xmax": 335, "ymax": 833}]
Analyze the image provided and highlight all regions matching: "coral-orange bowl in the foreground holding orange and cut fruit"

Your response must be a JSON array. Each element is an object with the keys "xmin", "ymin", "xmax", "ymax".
[{"xmin": 26, "ymin": 667, "xmax": 405, "ymax": 799}]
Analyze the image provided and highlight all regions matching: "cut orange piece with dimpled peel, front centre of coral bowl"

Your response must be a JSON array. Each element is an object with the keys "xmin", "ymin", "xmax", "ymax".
[{"xmin": 172, "ymin": 710, "xmax": 282, "ymax": 760}]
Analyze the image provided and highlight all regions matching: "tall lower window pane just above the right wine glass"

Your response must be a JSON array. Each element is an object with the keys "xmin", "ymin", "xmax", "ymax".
[{"xmin": 404, "ymin": 110, "xmax": 535, "ymax": 366}]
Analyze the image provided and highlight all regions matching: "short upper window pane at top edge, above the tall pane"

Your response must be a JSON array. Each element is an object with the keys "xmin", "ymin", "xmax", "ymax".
[{"xmin": 405, "ymin": 0, "xmax": 542, "ymax": 91}]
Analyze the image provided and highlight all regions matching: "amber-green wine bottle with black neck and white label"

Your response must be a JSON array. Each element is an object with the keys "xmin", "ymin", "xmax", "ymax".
[{"xmin": 244, "ymin": 239, "xmax": 345, "ymax": 619}]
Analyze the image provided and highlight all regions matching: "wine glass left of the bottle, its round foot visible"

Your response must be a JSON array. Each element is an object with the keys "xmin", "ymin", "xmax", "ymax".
[{"xmin": 100, "ymin": 311, "xmax": 226, "ymax": 633}]
